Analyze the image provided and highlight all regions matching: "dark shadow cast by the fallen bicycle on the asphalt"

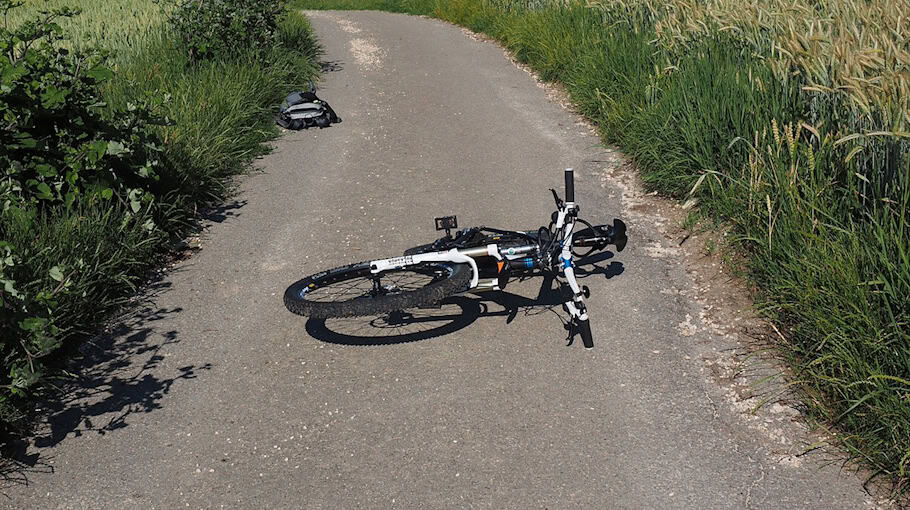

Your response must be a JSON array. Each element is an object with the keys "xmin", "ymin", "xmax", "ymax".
[{"xmin": 305, "ymin": 252, "xmax": 624, "ymax": 346}]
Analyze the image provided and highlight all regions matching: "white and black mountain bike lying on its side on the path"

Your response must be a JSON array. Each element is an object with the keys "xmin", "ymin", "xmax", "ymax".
[{"xmin": 284, "ymin": 168, "xmax": 627, "ymax": 349}]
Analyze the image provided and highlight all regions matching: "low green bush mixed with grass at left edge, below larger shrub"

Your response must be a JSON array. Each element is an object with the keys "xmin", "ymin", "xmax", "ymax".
[{"xmin": 0, "ymin": 203, "xmax": 167, "ymax": 431}]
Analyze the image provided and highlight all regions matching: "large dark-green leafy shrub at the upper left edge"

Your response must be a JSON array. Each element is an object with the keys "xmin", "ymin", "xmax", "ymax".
[{"xmin": 0, "ymin": 0, "xmax": 160, "ymax": 212}]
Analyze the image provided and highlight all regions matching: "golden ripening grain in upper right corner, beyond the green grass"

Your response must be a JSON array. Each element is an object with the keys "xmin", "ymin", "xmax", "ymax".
[{"xmin": 589, "ymin": 0, "xmax": 910, "ymax": 207}]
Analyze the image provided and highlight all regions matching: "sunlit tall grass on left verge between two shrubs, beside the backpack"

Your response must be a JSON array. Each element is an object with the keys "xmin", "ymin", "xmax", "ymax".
[{"xmin": 106, "ymin": 13, "xmax": 319, "ymax": 211}]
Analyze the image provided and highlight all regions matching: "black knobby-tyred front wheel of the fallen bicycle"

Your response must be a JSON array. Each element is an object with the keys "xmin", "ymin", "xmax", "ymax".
[{"xmin": 284, "ymin": 262, "xmax": 473, "ymax": 319}]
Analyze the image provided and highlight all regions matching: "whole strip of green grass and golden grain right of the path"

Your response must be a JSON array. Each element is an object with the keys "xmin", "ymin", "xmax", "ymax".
[{"xmin": 297, "ymin": 0, "xmax": 910, "ymax": 491}]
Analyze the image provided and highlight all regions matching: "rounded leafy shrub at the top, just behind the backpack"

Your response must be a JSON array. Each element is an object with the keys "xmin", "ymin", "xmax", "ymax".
[{"xmin": 168, "ymin": 0, "xmax": 285, "ymax": 61}]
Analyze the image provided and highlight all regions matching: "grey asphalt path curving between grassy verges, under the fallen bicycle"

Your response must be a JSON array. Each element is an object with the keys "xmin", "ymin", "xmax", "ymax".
[{"xmin": 0, "ymin": 8, "xmax": 880, "ymax": 509}]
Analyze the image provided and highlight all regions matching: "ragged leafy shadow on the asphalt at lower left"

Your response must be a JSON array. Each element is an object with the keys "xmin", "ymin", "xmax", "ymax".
[{"xmin": 0, "ymin": 278, "xmax": 212, "ymax": 491}]
